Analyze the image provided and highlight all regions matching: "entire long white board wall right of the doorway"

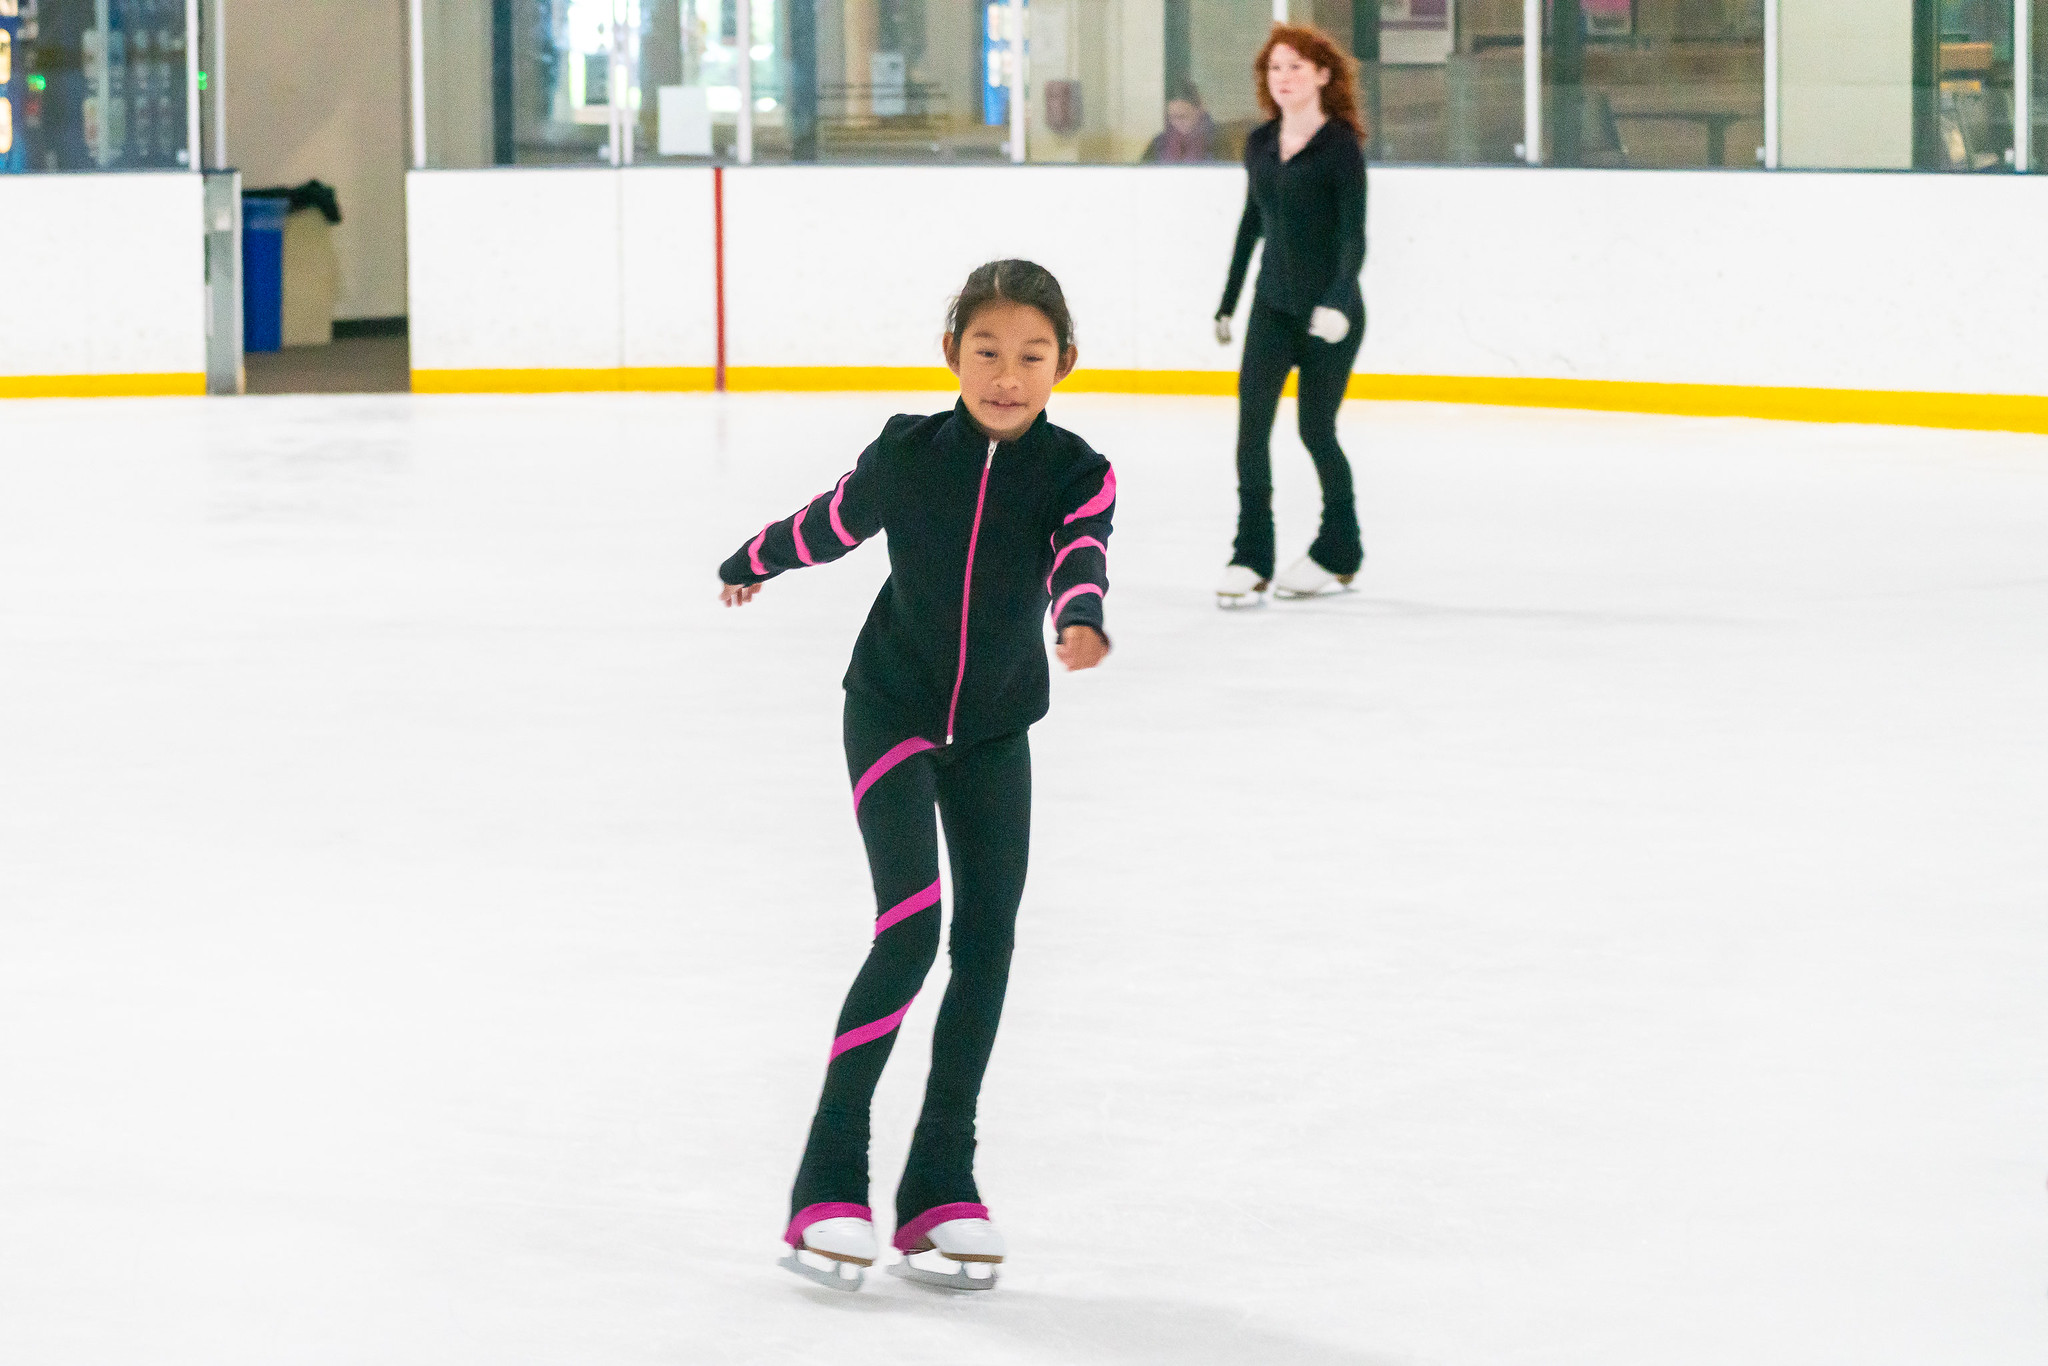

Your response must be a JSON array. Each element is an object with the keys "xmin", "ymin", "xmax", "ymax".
[{"xmin": 414, "ymin": 166, "xmax": 2048, "ymax": 395}]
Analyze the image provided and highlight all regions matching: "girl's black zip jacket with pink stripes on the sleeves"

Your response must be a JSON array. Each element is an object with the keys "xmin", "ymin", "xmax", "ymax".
[{"xmin": 719, "ymin": 403, "xmax": 1116, "ymax": 743}]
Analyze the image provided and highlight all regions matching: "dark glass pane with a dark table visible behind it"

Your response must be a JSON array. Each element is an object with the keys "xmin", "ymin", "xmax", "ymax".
[{"xmin": 1542, "ymin": 0, "xmax": 1763, "ymax": 168}]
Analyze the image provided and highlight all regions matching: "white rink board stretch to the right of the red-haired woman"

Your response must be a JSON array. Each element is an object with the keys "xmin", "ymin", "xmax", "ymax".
[{"xmin": 1358, "ymin": 168, "xmax": 2048, "ymax": 393}]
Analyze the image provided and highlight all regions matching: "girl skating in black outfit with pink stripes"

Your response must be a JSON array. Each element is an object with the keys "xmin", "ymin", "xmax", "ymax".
[{"xmin": 719, "ymin": 260, "xmax": 1116, "ymax": 1290}]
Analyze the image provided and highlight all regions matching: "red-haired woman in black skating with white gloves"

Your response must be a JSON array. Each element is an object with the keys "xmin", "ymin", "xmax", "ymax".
[{"xmin": 1217, "ymin": 25, "xmax": 1366, "ymax": 606}]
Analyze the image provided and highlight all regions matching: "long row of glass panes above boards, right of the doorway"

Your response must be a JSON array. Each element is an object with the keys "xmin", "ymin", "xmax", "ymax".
[{"xmin": 407, "ymin": 0, "xmax": 2048, "ymax": 172}]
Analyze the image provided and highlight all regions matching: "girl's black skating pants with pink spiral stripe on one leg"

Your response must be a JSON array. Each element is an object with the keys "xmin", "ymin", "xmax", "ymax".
[{"xmin": 791, "ymin": 694, "xmax": 1030, "ymax": 1229}]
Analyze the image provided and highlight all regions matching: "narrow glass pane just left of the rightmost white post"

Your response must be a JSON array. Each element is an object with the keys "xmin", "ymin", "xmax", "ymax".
[{"xmin": 1913, "ymin": 0, "xmax": 2013, "ymax": 170}]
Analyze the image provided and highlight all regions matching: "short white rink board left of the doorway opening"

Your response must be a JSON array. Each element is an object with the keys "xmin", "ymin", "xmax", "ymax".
[{"xmin": 0, "ymin": 174, "xmax": 207, "ymax": 377}]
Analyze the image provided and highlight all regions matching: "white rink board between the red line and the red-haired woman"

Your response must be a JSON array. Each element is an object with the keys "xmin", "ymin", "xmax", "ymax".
[{"xmin": 725, "ymin": 166, "xmax": 1243, "ymax": 371}]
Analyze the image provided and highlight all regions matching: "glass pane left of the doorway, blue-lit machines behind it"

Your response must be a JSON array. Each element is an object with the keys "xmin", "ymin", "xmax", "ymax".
[{"xmin": 0, "ymin": 0, "xmax": 190, "ymax": 172}]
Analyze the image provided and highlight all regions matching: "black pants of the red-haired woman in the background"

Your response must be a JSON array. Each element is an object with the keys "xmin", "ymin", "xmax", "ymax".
[{"xmin": 1231, "ymin": 303, "xmax": 1366, "ymax": 578}]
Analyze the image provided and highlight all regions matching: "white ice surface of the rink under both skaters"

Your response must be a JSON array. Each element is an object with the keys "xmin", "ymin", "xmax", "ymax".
[{"xmin": 0, "ymin": 395, "xmax": 2048, "ymax": 1366}]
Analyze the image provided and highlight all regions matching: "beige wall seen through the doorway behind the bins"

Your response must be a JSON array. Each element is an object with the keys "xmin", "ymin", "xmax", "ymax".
[{"xmin": 223, "ymin": 0, "xmax": 410, "ymax": 317}]
